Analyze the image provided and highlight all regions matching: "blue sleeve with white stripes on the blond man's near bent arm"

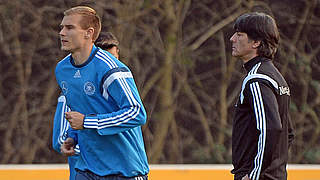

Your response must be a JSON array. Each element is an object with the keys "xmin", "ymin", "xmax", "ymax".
[{"xmin": 84, "ymin": 68, "xmax": 147, "ymax": 135}]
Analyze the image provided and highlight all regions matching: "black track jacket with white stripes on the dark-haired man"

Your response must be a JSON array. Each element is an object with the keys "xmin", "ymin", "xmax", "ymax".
[{"xmin": 231, "ymin": 57, "xmax": 294, "ymax": 180}]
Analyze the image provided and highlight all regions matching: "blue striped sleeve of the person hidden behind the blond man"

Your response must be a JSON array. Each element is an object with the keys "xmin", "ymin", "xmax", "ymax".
[{"xmin": 52, "ymin": 95, "xmax": 71, "ymax": 153}]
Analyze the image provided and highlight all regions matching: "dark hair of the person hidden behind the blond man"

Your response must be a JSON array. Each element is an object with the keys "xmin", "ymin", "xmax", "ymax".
[{"xmin": 96, "ymin": 32, "xmax": 119, "ymax": 50}]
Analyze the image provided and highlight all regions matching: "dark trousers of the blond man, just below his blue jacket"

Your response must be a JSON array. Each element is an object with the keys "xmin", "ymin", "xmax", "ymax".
[{"xmin": 75, "ymin": 170, "xmax": 148, "ymax": 180}]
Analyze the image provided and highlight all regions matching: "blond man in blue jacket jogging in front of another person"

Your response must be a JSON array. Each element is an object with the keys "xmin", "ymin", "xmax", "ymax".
[{"xmin": 55, "ymin": 6, "xmax": 149, "ymax": 180}]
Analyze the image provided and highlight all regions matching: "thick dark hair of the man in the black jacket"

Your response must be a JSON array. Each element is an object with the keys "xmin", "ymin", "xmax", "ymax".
[{"xmin": 233, "ymin": 12, "xmax": 280, "ymax": 59}]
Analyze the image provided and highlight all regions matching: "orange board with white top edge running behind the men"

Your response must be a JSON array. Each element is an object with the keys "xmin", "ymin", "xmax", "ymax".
[{"xmin": 0, "ymin": 164, "xmax": 320, "ymax": 180}]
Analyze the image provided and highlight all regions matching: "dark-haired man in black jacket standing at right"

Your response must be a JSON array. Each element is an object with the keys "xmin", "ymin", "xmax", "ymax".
[{"xmin": 230, "ymin": 12, "xmax": 294, "ymax": 180}]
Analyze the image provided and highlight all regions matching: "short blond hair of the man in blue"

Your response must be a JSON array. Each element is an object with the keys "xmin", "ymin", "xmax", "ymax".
[{"xmin": 63, "ymin": 6, "xmax": 101, "ymax": 42}]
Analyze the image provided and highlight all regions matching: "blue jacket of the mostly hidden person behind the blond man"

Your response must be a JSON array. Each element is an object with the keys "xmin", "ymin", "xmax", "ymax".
[{"xmin": 52, "ymin": 95, "xmax": 80, "ymax": 180}]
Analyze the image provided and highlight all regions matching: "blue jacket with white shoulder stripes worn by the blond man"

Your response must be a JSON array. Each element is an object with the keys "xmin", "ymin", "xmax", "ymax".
[{"xmin": 55, "ymin": 45, "xmax": 149, "ymax": 177}]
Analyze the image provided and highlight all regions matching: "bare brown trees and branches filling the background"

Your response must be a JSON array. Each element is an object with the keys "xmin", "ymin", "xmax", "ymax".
[{"xmin": 0, "ymin": 0, "xmax": 320, "ymax": 163}]
